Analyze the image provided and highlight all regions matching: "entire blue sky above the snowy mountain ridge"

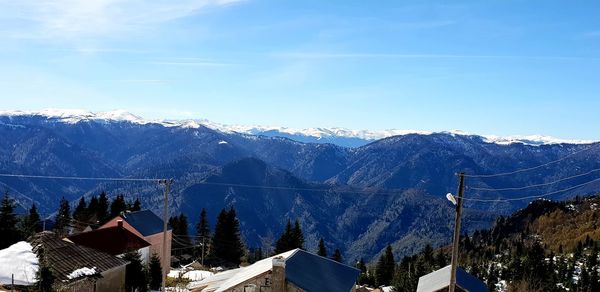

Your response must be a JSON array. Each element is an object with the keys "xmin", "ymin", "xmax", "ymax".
[{"xmin": 0, "ymin": 0, "xmax": 600, "ymax": 139}]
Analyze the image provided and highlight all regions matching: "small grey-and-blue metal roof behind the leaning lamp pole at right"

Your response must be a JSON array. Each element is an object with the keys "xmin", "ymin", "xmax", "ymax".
[{"xmin": 417, "ymin": 265, "xmax": 489, "ymax": 292}]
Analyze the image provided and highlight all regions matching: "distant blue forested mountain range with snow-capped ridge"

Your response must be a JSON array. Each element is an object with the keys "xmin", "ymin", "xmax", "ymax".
[{"xmin": 0, "ymin": 110, "xmax": 600, "ymax": 261}]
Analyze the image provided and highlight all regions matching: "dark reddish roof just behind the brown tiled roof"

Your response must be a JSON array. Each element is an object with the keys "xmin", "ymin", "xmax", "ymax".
[{"xmin": 68, "ymin": 225, "xmax": 150, "ymax": 255}]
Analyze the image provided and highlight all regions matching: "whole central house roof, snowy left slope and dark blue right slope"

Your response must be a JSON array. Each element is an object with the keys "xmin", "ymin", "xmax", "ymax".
[{"xmin": 188, "ymin": 249, "xmax": 360, "ymax": 292}]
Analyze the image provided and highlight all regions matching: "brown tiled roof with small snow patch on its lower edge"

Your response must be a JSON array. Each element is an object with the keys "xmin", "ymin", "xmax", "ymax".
[{"xmin": 29, "ymin": 231, "xmax": 128, "ymax": 281}]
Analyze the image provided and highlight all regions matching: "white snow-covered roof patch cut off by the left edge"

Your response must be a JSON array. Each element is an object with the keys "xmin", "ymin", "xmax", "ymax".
[{"xmin": 0, "ymin": 241, "xmax": 38, "ymax": 286}]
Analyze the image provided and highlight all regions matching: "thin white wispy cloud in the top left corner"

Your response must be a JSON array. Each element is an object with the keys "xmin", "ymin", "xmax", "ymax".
[{"xmin": 0, "ymin": 0, "xmax": 240, "ymax": 39}]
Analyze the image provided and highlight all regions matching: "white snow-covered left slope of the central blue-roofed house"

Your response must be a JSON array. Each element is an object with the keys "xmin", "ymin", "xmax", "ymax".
[{"xmin": 188, "ymin": 249, "xmax": 298, "ymax": 292}]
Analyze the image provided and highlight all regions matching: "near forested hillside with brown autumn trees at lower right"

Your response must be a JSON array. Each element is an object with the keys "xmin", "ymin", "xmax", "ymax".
[{"xmin": 384, "ymin": 195, "xmax": 600, "ymax": 291}]
